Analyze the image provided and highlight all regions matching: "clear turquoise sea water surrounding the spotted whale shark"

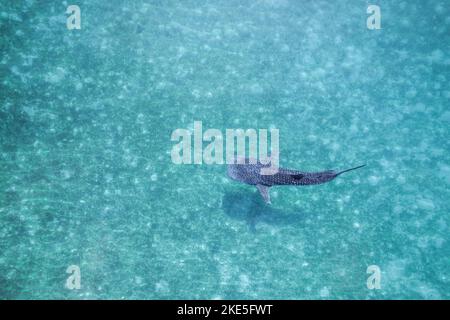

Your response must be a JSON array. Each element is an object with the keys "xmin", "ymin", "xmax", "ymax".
[{"xmin": 0, "ymin": 0, "xmax": 450, "ymax": 299}]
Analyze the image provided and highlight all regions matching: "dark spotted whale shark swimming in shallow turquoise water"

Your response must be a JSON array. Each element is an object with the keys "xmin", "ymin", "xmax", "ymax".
[{"xmin": 227, "ymin": 158, "xmax": 365, "ymax": 204}]
